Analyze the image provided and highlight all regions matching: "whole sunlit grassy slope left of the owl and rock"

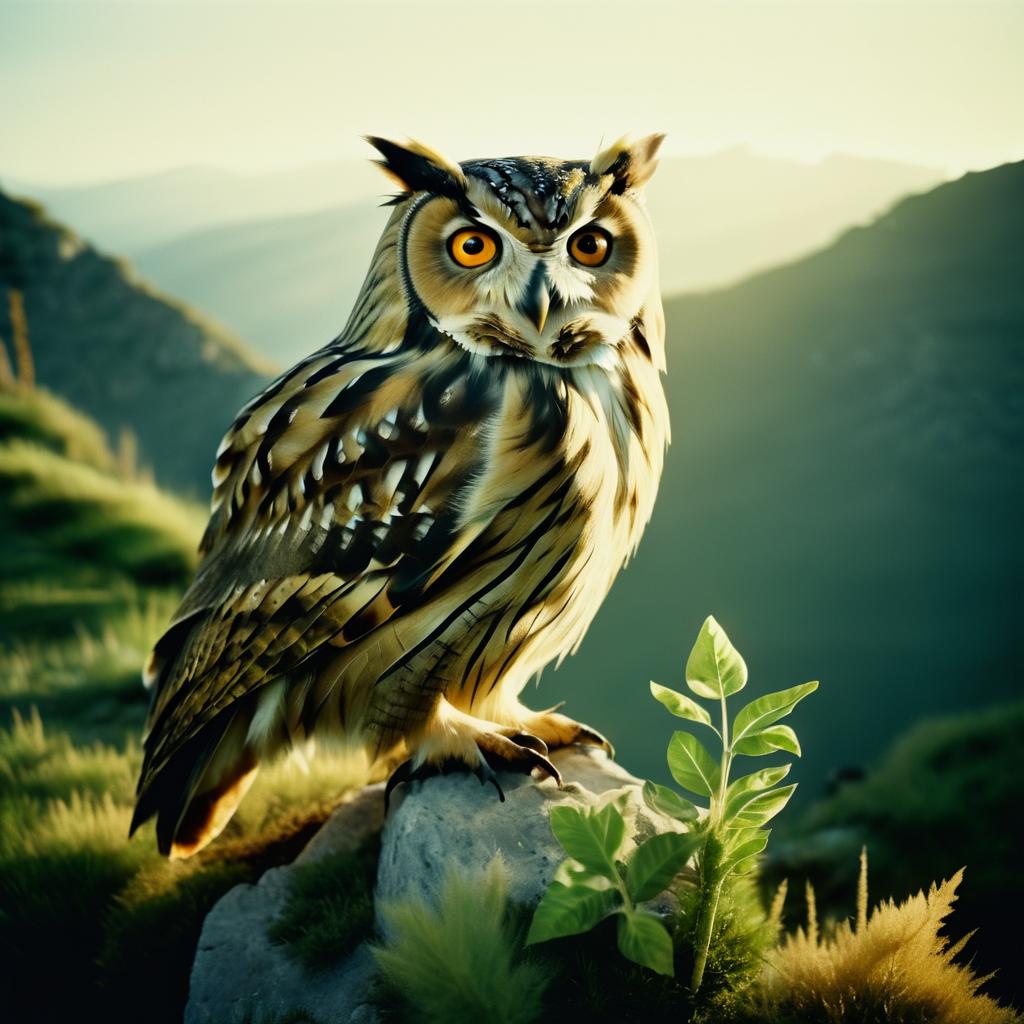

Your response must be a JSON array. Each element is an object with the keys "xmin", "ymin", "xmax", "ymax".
[{"xmin": 0, "ymin": 388, "xmax": 364, "ymax": 1022}]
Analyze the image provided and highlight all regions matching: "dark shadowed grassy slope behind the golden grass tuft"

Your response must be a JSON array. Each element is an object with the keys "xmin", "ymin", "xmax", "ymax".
[{"xmin": 768, "ymin": 702, "xmax": 1024, "ymax": 997}]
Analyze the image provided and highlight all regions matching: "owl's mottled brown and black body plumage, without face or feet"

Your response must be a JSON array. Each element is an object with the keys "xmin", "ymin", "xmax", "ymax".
[{"xmin": 130, "ymin": 138, "xmax": 668, "ymax": 853}]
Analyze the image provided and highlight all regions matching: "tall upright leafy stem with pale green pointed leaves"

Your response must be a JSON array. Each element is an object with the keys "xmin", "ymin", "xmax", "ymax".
[{"xmin": 644, "ymin": 615, "xmax": 818, "ymax": 992}]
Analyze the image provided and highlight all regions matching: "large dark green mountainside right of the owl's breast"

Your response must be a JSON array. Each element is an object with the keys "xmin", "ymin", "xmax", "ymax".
[{"xmin": 552, "ymin": 157, "xmax": 1024, "ymax": 798}]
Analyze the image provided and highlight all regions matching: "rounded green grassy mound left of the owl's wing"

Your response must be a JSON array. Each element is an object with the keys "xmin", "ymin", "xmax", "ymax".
[{"xmin": 0, "ymin": 388, "xmax": 206, "ymax": 647}]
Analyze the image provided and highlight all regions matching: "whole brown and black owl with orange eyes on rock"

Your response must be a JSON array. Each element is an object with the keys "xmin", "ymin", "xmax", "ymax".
[{"xmin": 132, "ymin": 135, "xmax": 669, "ymax": 857}]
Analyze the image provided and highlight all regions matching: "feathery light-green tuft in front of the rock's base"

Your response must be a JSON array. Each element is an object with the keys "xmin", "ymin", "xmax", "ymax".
[{"xmin": 373, "ymin": 856, "xmax": 550, "ymax": 1024}]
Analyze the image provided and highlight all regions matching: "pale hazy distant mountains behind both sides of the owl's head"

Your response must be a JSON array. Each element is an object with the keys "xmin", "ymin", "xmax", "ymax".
[{"xmin": 12, "ymin": 148, "xmax": 942, "ymax": 362}]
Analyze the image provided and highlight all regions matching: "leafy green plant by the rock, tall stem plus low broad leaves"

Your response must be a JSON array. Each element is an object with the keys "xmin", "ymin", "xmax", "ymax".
[{"xmin": 526, "ymin": 616, "xmax": 818, "ymax": 992}]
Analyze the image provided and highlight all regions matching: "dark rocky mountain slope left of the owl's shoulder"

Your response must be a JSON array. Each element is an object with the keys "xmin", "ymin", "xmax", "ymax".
[{"xmin": 0, "ymin": 193, "xmax": 270, "ymax": 498}]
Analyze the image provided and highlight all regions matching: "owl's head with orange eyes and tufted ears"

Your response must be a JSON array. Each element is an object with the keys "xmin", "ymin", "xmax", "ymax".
[{"xmin": 369, "ymin": 135, "xmax": 664, "ymax": 367}]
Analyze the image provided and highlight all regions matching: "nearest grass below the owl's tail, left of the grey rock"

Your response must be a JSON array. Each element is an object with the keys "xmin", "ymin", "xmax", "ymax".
[{"xmin": 0, "ymin": 700, "xmax": 362, "ymax": 1021}]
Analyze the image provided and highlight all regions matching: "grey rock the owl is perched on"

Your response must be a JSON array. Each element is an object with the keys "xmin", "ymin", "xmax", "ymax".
[{"xmin": 185, "ymin": 749, "xmax": 681, "ymax": 1024}]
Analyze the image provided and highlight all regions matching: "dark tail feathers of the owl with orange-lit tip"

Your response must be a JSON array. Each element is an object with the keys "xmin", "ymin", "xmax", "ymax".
[{"xmin": 129, "ymin": 720, "xmax": 259, "ymax": 860}]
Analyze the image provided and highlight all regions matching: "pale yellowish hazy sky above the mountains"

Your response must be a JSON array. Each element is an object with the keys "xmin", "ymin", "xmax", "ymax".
[{"xmin": 0, "ymin": 0, "xmax": 1024, "ymax": 183}]
